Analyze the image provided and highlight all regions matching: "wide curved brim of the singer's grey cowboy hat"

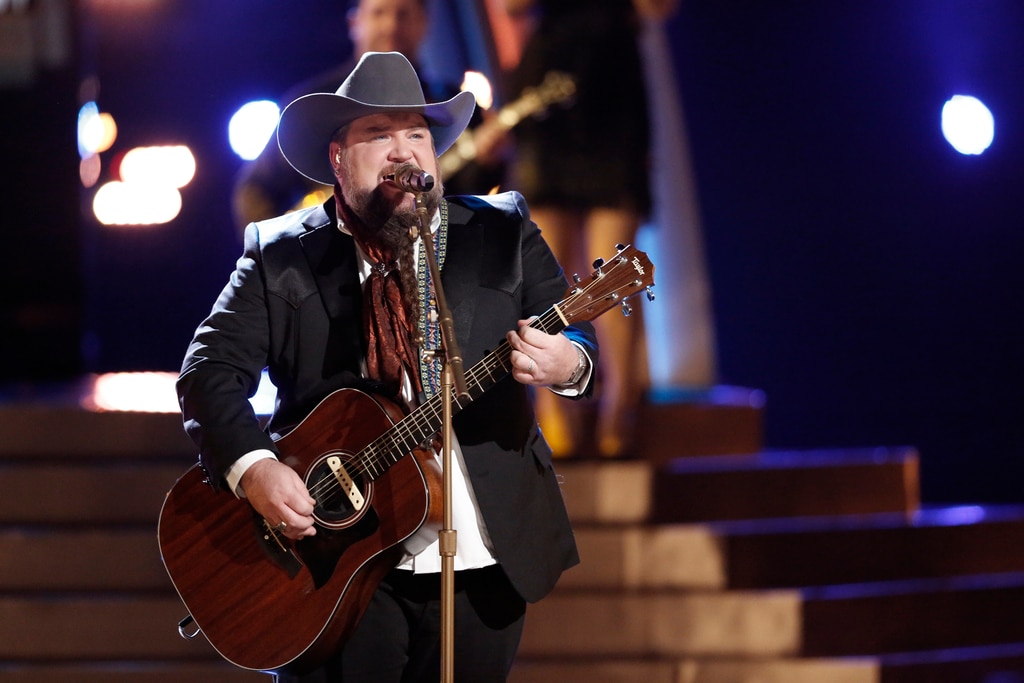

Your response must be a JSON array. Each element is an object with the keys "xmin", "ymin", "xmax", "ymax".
[{"xmin": 278, "ymin": 91, "xmax": 476, "ymax": 185}]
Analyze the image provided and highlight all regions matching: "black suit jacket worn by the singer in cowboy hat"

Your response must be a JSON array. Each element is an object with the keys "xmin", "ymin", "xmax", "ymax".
[{"xmin": 178, "ymin": 193, "xmax": 597, "ymax": 601}]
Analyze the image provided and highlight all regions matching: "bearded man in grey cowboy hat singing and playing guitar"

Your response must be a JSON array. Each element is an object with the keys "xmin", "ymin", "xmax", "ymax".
[{"xmin": 177, "ymin": 52, "xmax": 597, "ymax": 683}]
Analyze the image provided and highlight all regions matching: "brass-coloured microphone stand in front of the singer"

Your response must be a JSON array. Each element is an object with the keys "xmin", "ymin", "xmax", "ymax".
[{"xmin": 415, "ymin": 188, "xmax": 469, "ymax": 683}]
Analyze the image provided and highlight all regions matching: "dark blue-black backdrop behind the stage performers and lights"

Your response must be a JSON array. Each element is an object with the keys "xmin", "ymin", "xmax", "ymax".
[{"xmin": 0, "ymin": 0, "xmax": 1024, "ymax": 502}]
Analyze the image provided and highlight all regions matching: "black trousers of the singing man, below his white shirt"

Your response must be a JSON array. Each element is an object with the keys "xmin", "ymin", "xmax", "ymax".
[{"xmin": 276, "ymin": 565, "xmax": 526, "ymax": 683}]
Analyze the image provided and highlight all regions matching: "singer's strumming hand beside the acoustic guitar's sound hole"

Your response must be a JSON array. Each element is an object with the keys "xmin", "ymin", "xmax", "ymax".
[{"xmin": 241, "ymin": 458, "xmax": 316, "ymax": 541}]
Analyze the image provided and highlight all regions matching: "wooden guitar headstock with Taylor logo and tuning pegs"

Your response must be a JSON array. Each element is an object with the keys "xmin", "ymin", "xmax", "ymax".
[{"xmin": 555, "ymin": 245, "xmax": 654, "ymax": 325}]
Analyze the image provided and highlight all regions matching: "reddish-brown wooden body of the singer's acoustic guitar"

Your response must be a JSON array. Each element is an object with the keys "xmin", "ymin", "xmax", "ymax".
[{"xmin": 158, "ymin": 389, "xmax": 442, "ymax": 672}]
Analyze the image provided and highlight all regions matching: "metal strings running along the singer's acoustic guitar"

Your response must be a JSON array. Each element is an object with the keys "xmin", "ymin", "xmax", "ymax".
[{"xmin": 301, "ymin": 255, "xmax": 628, "ymax": 505}]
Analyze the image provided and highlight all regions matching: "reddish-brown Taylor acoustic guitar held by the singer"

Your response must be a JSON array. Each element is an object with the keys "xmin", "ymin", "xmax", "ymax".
[{"xmin": 157, "ymin": 246, "xmax": 654, "ymax": 672}]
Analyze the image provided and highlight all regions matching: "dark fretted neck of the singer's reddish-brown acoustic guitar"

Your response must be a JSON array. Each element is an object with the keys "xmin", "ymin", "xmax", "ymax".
[{"xmin": 358, "ymin": 305, "xmax": 566, "ymax": 479}]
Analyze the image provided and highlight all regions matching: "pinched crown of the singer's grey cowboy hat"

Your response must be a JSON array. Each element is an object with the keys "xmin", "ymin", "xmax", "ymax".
[{"xmin": 336, "ymin": 52, "xmax": 427, "ymax": 106}]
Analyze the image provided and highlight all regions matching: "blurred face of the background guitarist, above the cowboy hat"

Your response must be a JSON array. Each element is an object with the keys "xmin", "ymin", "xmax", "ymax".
[{"xmin": 348, "ymin": 0, "xmax": 427, "ymax": 57}]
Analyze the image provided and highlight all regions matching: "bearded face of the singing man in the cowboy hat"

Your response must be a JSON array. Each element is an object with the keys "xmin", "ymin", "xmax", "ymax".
[{"xmin": 331, "ymin": 114, "xmax": 442, "ymax": 232}]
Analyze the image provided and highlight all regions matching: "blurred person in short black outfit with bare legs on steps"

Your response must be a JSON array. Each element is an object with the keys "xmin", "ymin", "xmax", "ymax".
[{"xmin": 506, "ymin": 0, "xmax": 678, "ymax": 458}]
